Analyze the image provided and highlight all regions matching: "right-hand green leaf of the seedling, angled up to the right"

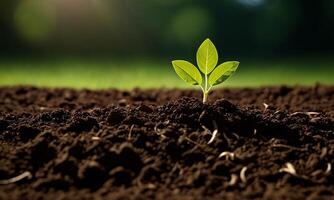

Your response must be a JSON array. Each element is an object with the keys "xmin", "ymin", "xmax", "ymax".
[{"xmin": 209, "ymin": 61, "xmax": 239, "ymax": 86}]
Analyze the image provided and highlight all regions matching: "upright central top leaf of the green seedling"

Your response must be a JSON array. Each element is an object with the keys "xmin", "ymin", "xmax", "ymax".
[{"xmin": 196, "ymin": 39, "xmax": 218, "ymax": 74}]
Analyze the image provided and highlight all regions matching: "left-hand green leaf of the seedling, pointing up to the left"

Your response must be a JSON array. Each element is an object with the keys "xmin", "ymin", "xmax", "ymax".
[{"xmin": 172, "ymin": 60, "xmax": 202, "ymax": 85}]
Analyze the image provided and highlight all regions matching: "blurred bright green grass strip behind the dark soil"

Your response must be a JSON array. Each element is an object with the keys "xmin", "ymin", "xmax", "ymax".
[{"xmin": 0, "ymin": 58, "xmax": 334, "ymax": 89}]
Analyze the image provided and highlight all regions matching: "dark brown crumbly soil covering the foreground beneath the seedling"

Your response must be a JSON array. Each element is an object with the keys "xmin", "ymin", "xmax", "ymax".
[{"xmin": 0, "ymin": 85, "xmax": 334, "ymax": 200}]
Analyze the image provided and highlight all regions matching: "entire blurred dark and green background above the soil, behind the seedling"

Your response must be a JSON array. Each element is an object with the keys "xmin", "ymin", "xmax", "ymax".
[{"xmin": 0, "ymin": 0, "xmax": 334, "ymax": 88}]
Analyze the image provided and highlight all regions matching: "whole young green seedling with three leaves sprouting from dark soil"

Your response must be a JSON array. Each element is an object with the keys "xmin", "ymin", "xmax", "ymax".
[{"xmin": 172, "ymin": 39, "xmax": 239, "ymax": 103}]
